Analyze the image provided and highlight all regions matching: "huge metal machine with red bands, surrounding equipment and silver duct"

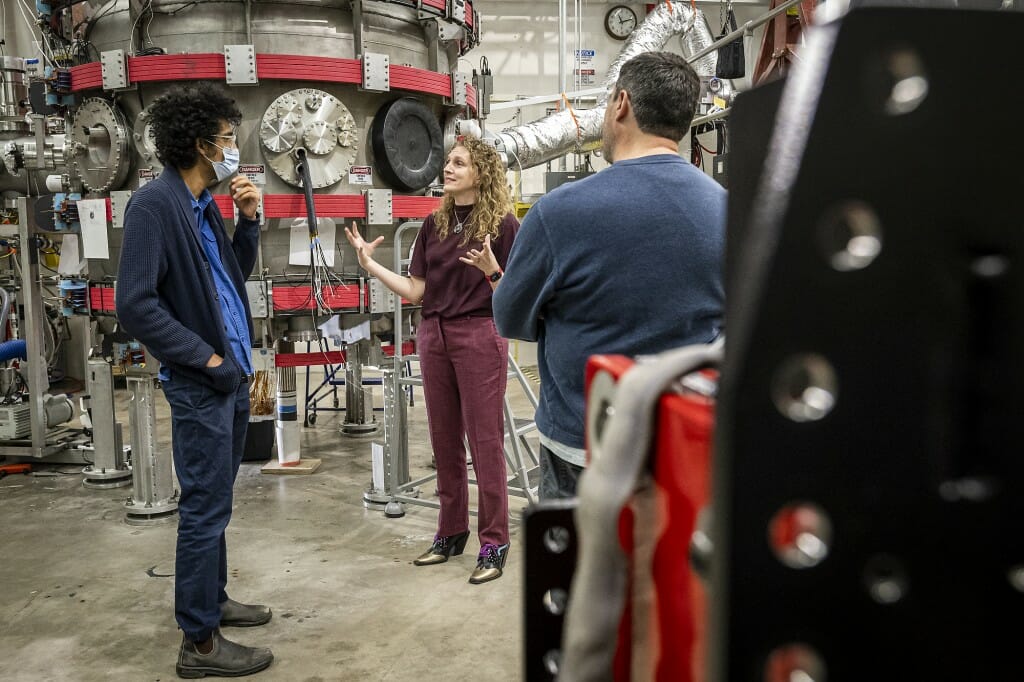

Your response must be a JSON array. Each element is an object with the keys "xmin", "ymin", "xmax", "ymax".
[{"xmin": 0, "ymin": 0, "xmax": 716, "ymax": 521}]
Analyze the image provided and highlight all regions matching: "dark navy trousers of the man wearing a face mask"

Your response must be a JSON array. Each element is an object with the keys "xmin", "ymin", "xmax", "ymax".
[{"xmin": 164, "ymin": 375, "xmax": 249, "ymax": 642}]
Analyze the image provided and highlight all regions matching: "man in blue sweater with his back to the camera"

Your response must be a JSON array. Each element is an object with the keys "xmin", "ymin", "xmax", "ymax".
[{"xmin": 494, "ymin": 52, "xmax": 726, "ymax": 500}]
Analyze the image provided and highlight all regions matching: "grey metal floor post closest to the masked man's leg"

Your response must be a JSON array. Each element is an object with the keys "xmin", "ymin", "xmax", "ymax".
[{"xmin": 125, "ymin": 376, "xmax": 178, "ymax": 525}]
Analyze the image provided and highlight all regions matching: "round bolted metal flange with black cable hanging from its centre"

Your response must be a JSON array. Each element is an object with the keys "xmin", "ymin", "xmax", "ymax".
[{"xmin": 259, "ymin": 88, "xmax": 358, "ymax": 188}]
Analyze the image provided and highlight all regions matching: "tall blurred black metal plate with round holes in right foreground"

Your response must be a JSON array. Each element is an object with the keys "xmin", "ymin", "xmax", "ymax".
[{"xmin": 709, "ymin": 8, "xmax": 1024, "ymax": 682}]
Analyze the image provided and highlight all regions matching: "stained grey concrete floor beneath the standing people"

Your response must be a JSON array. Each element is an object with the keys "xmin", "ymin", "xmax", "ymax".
[{"xmin": 0, "ymin": 368, "xmax": 530, "ymax": 682}]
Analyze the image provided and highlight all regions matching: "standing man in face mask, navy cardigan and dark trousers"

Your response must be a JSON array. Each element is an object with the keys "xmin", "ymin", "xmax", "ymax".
[{"xmin": 117, "ymin": 82, "xmax": 273, "ymax": 678}]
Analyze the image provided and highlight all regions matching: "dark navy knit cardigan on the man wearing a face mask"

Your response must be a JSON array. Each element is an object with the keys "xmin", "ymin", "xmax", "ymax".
[{"xmin": 116, "ymin": 167, "xmax": 259, "ymax": 393}]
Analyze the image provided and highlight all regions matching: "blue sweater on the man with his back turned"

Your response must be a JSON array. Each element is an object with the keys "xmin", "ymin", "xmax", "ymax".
[{"xmin": 494, "ymin": 155, "xmax": 726, "ymax": 447}]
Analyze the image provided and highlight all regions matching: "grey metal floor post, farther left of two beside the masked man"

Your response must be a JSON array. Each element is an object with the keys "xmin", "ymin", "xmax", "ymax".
[{"xmin": 81, "ymin": 359, "xmax": 132, "ymax": 488}]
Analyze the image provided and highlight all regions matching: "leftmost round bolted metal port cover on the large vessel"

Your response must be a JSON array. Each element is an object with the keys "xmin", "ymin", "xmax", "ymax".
[{"xmin": 68, "ymin": 97, "xmax": 131, "ymax": 191}]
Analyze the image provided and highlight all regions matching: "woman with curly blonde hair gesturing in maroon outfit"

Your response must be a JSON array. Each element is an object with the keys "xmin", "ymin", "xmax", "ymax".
[{"xmin": 345, "ymin": 137, "xmax": 519, "ymax": 584}]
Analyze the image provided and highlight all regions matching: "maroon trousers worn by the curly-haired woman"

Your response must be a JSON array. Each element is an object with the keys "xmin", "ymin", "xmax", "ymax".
[{"xmin": 417, "ymin": 317, "xmax": 509, "ymax": 546}]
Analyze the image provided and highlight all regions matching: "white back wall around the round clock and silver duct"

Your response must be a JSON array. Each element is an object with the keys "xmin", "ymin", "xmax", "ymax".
[{"xmin": 471, "ymin": 0, "xmax": 769, "ymax": 196}]
